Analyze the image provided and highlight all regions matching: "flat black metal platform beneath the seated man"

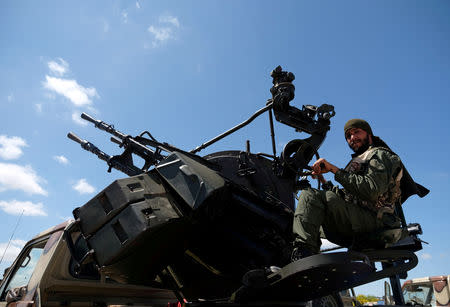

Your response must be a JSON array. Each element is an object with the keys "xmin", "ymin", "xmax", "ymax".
[{"xmin": 233, "ymin": 250, "xmax": 417, "ymax": 305}]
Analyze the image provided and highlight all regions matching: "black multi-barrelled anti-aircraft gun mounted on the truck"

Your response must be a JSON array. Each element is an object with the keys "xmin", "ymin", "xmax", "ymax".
[{"xmin": 65, "ymin": 66, "xmax": 422, "ymax": 305}]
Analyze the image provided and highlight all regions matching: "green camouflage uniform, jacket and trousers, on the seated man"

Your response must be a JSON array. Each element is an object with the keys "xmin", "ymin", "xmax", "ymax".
[{"xmin": 293, "ymin": 146, "xmax": 402, "ymax": 253}]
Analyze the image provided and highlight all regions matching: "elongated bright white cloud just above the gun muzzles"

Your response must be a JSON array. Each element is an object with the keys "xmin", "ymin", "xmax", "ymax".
[{"xmin": 44, "ymin": 76, "xmax": 99, "ymax": 107}]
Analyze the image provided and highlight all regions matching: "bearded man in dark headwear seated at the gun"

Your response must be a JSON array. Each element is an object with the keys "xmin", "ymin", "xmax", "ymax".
[{"xmin": 292, "ymin": 119, "xmax": 428, "ymax": 260}]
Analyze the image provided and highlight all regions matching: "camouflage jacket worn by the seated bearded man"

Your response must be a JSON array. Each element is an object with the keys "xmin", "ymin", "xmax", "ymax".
[{"xmin": 335, "ymin": 146, "xmax": 403, "ymax": 218}]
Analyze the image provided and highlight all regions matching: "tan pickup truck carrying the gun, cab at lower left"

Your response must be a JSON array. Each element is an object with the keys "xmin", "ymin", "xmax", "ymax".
[{"xmin": 0, "ymin": 220, "xmax": 177, "ymax": 307}]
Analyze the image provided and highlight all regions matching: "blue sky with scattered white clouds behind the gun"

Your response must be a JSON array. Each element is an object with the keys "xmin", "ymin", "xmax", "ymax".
[{"xmin": 0, "ymin": 0, "xmax": 450, "ymax": 295}]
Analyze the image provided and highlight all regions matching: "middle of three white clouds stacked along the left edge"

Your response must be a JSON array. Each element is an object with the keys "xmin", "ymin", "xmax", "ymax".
[{"xmin": 0, "ymin": 163, "xmax": 48, "ymax": 196}]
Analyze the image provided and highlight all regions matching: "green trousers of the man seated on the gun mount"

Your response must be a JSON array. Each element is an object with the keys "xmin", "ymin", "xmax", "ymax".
[{"xmin": 293, "ymin": 188, "xmax": 398, "ymax": 252}]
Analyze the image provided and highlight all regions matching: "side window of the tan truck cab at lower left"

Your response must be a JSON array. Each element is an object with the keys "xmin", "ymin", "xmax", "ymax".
[{"xmin": 0, "ymin": 242, "xmax": 45, "ymax": 299}]
